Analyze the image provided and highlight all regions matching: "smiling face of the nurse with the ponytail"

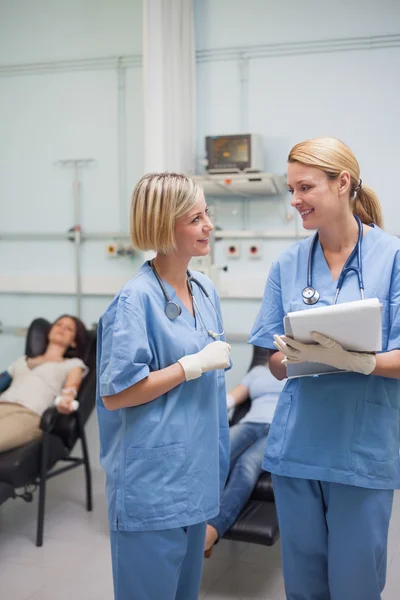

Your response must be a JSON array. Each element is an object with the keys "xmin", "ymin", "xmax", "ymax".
[{"xmin": 287, "ymin": 162, "xmax": 350, "ymax": 229}]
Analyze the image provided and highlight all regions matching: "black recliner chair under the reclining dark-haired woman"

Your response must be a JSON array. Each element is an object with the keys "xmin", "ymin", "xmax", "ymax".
[{"xmin": 0, "ymin": 319, "xmax": 97, "ymax": 546}]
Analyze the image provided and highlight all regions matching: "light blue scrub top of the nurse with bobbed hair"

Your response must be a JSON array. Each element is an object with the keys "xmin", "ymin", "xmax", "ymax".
[{"xmin": 96, "ymin": 263, "xmax": 229, "ymax": 531}]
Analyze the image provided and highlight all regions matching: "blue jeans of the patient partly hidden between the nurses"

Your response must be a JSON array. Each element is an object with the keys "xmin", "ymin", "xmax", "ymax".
[{"xmin": 208, "ymin": 422, "xmax": 269, "ymax": 538}]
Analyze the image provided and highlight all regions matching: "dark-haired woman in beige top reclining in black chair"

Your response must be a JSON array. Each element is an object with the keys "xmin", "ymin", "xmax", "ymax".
[{"xmin": 0, "ymin": 315, "xmax": 88, "ymax": 452}]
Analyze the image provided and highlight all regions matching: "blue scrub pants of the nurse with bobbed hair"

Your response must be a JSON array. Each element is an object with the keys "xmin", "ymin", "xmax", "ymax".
[{"xmin": 111, "ymin": 523, "xmax": 206, "ymax": 600}]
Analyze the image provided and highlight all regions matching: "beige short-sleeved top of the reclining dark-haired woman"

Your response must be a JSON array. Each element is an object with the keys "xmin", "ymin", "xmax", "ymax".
[{"xmin": 0, "ymin": 356, "xmax": 88, "ymax": 415}]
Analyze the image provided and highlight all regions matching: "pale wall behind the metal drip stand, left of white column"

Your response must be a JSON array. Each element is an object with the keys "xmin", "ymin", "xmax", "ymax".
[{"xmin": 0, "ymin": 0, "xmax": 143, "ymax": 364}]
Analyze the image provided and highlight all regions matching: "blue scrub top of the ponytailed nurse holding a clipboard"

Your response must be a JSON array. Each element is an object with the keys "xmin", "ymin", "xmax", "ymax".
[{"xmin": 249, "ymin": 226, "xmax": 400, "ymax": 489}]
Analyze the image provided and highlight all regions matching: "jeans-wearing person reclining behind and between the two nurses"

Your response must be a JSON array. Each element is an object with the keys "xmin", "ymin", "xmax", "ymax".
[{"xmin": 204, "ymin": 365, "xmax": 285, "ymax": 558}]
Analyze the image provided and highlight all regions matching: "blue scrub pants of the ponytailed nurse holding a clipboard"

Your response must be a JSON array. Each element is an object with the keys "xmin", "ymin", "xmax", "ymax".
[{"xmin": 272, "ymin": 475, "xmax": 393, "ymax": 600}]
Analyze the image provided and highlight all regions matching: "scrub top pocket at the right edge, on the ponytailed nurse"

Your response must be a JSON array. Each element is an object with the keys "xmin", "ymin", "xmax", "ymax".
[{"xmin": 351, "ymin": 401, "xmax": 399, "ymax": 479}]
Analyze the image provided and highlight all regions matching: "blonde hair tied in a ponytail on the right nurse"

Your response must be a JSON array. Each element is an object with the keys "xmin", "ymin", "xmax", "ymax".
[{"xmin": 288, "ymin": 137, "xmax": 383, "ymax": 228}]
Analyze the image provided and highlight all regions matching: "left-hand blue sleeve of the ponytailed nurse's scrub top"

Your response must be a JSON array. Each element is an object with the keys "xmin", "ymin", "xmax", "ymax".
[{"xmin": 248, "ymin": 263, "xmax": 285, "ymax": 350}]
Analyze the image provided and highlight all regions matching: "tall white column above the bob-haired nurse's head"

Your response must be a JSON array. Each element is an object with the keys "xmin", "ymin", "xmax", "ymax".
[{"xmin": 143, "ymin": 0, "xmax": 196, "ymax": 175}]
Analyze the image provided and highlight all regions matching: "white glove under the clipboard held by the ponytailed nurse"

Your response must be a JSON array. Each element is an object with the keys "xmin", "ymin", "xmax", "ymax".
[{"xmin": 274, "ymin": 332, "xmax": 376, "ymax": 375}]
